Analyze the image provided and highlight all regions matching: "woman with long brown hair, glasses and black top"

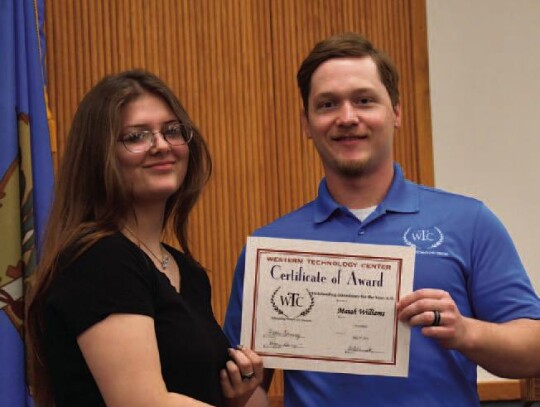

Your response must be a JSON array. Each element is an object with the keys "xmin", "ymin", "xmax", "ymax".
[{"xmin": 28, "ymin": 70, "xmax": 262, "ymax": 407}]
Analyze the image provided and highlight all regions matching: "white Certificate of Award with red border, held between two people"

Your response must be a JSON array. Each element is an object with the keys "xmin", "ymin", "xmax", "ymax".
[{"xmin": 241, "ymin": 237, "xmax": 415, "ymax": 377}]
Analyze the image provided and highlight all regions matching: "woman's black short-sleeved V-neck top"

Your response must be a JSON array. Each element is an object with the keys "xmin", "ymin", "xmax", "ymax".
[{"xmin": 43, "ymin": 233, "xmax": 230, "ymax": 407}]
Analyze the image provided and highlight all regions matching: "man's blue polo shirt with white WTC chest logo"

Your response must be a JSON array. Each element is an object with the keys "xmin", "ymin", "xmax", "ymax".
[{"xmin": 224, "ymin": 164, "xmax": 540, "ymax": 407}]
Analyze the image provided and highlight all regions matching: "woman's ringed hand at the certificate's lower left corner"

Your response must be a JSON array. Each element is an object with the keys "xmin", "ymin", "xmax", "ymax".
[{"xmin": 220, "ymin": 345, "xmax": 263, "ymax": 407}]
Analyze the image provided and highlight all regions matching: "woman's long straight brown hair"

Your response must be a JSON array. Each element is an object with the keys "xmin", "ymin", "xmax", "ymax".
[{"xmin": 26, "ymin": 70, "xmax": 212, "ymax": 407}]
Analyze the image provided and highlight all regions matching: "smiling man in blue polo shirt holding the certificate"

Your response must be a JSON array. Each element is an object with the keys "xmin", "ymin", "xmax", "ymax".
[{"xmin": 225, "ymin": 34, "xmax": 540, "ymax": 407}]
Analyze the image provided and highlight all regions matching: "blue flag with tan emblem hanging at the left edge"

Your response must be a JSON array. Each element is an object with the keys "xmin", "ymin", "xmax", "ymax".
[{"xmin": 0, "ymin": 0, "xmax": 53, "ymax": 407}]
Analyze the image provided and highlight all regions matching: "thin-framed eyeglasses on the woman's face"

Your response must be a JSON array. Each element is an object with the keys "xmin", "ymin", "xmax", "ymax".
[{"xmin": 118, "ymin": 123, "xmax": 193, "ymax": 153}]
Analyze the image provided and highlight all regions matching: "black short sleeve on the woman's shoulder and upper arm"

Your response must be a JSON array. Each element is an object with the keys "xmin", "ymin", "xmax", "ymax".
[{"xmin": 46, "ymin": 234, "xmax": 155, "ymax": 336}]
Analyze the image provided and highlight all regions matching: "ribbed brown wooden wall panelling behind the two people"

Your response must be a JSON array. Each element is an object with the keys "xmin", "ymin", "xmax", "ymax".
[{"xmin": 45, "ymin": 0, "xmax": 433, "ymax": 404}]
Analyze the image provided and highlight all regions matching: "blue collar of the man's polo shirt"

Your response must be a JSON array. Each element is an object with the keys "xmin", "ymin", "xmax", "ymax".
[{"xmin": 314, "ymin": 163, "xmax": 419, "ymax": 223}]
